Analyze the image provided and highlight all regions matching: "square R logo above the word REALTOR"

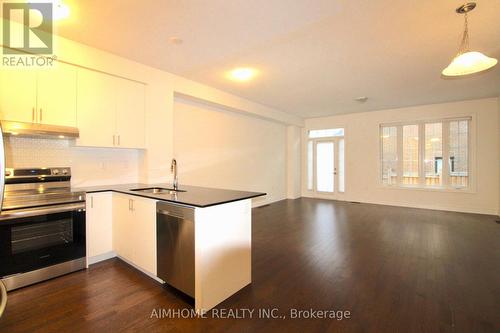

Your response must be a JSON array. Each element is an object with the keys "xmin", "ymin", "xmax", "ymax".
[{"xmin": 2, "ymin": 3, "xmax": 53, "ymax": 55}]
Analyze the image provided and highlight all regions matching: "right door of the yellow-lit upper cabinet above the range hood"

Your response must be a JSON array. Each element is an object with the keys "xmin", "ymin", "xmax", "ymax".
[{"xmin": 37, "ymin": 62, "xmax": 77, "ymax": 127}]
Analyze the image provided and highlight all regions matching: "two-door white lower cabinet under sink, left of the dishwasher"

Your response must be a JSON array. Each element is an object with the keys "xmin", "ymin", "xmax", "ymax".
[{"xmin": 113, "ymin": 193, "xmax": 156, "ymax": 276}]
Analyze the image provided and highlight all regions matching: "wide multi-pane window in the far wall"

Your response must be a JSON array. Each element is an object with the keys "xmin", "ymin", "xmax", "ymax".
[{"xmin": 380, "ymin": 118, "xmax": 471, "ymax": 189}]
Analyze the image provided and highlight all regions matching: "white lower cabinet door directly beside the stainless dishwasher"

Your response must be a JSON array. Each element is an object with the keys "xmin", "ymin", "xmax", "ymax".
[{"xmin": 132, "ymin": 197, "xmax": 156, "ymax": 276}]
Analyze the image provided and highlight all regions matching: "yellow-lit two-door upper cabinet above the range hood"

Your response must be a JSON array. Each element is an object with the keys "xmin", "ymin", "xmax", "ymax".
[{"xmin": 0, "ymin": 63, "xmax": 76, "ymax": 127}]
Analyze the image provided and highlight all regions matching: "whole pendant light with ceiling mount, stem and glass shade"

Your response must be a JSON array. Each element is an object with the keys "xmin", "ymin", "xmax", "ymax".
[{"xmin": 442, "ymin": 2, "xmax": 498, "ymax": 77}]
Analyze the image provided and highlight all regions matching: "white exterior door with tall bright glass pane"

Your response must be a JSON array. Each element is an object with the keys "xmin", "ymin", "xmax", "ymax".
[{"xmin": 313, "ymin": 137, "xmax": 345, "ymax": 199}]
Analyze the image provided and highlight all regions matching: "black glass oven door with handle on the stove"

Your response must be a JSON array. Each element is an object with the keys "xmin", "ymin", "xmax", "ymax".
[{"xmin": 0, "ymin": 203, "xmax": 85, "ymax": 277}]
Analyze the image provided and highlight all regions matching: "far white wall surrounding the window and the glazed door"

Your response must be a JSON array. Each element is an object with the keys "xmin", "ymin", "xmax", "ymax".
[{"xmin": 302, "ymin": 98, "xmax": 500, "ymax": 214}]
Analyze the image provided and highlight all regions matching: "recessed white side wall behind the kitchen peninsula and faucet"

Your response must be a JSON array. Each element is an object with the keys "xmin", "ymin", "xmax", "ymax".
[{"xmin": 174, "ymin": 98, "xmax": 287, "ymax": 205}]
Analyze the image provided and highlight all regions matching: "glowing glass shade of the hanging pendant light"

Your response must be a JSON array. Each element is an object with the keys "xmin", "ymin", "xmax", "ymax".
[{"xmin": 442, "ymin": 51, "xmax": 498, "ymax": 76}]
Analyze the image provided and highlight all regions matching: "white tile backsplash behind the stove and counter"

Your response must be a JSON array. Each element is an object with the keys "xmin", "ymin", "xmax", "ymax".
[{"xmin": 5, "ymin": 136, "xmax": 143, "ymax": 186}]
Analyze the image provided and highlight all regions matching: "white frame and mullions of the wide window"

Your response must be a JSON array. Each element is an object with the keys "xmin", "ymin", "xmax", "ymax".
[{"xmin": 377, "ymin": 114, "xmax": 476, "ymax": 193}]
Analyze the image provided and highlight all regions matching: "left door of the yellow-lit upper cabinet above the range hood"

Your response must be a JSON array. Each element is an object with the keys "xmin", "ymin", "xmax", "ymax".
[{"xmin": 0, "ymin": 68, "xmax": 37, "ymax": 123}]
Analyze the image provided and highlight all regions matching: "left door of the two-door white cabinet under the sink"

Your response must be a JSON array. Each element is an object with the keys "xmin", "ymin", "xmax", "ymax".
[{"xmin": 113, "ymin": 194, "xmax": 137, "ymax": 262}]
